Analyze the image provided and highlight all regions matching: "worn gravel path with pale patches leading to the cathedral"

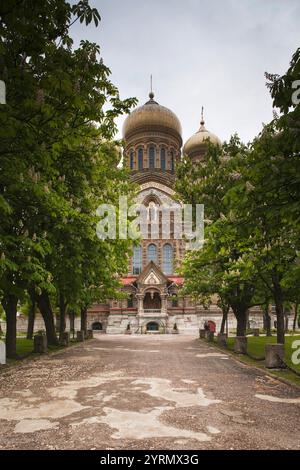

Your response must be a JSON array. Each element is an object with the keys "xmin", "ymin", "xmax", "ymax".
[{"xmin": 0, "ymin": 334, "xmax": 300, "ymax": 450}]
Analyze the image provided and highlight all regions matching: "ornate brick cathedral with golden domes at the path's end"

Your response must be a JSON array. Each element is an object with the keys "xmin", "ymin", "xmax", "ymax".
[{"xmin": 88, "ymin": 92, "xmax": 260, "ymax": 335}]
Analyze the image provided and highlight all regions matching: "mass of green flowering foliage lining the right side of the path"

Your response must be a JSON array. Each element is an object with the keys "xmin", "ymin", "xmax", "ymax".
[{"xmin": 177, "ymin": 49, "xmax": 300, "ymax": 342}]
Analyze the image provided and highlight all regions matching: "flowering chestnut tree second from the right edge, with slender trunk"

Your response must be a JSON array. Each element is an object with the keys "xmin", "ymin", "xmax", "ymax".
[{"xmin": 227, "ymin": 120, "xmax": 299, "ymax": 343}]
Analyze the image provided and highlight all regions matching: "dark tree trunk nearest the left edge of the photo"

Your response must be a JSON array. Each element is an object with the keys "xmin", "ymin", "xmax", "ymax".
[{"xmin": 2, "ymin": 295, "xmax": 18, "ymax": 359}]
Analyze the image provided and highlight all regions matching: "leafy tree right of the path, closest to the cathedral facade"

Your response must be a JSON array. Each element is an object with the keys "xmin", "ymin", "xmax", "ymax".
[{"xmin": 177, "ymin": 136, "xmax": 261, "ymax": 336}]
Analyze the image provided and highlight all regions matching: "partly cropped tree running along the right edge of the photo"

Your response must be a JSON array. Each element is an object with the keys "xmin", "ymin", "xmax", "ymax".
[{"xmin": 266, "ymin": 48, "xmax": 300, "ymax": 338}]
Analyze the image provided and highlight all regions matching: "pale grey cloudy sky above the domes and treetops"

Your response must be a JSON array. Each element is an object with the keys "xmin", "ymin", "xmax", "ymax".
[{"xmin": 72, "ymin": 0, "xmax": 300, "ymax": 142}]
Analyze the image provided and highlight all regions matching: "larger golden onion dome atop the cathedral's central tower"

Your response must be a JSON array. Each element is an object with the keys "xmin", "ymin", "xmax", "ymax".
[{"xmin": 123, "ymin": 92, "xmax": 182, "ymax": 140}]
